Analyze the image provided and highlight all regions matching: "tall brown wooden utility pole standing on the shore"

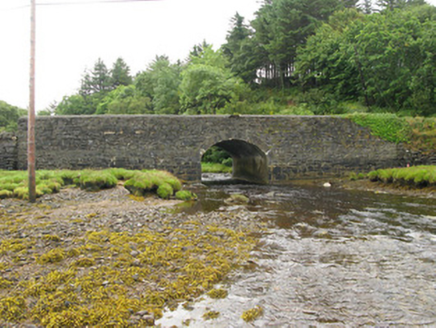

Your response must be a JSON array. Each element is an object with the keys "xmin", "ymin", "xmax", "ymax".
[{"xmin": 27, "ymin": 0, "xmax": 36, "ymax": 203}]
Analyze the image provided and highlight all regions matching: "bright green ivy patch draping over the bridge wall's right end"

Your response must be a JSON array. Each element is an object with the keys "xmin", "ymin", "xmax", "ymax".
[{"xmin": 344, "ymin": 113, "xmax": 411, "ymax": 143}]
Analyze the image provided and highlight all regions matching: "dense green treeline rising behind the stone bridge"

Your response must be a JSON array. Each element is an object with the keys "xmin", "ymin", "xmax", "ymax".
[{"xmin": 37, "ymin": 0, "xmax": 436, "ymax": 116}]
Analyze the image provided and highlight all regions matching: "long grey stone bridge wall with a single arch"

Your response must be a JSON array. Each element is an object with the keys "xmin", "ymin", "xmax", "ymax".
[{"xmin": 0, "ymin": 115, "xmax": 404, "ymax": 183}]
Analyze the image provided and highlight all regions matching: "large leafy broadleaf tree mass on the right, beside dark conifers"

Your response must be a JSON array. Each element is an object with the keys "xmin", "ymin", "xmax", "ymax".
[{"xmin": 296, "ymin": 6, "xmax": 436, "ymax": 115}]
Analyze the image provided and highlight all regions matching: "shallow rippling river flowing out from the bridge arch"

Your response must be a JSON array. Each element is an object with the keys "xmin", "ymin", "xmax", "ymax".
[{"xmin": 157, "ymin": 178, "xmax": 436, "ymax": 327}]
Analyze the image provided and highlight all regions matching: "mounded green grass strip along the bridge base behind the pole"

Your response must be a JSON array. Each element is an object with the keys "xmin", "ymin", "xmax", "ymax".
[{"xmin": 0, "ymin": 169, "xmax": 186, "ymax": 199}]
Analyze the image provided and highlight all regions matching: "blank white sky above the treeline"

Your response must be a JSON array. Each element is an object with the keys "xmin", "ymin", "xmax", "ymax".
[{"xmin": 0, "ymin": 0, "xmax": 262, "ymax": 111}]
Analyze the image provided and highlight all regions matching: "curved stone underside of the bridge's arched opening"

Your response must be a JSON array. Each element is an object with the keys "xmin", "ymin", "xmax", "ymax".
[{"xmin": 200, "ymin": 139, "xmax": 269, "ymax": 184}]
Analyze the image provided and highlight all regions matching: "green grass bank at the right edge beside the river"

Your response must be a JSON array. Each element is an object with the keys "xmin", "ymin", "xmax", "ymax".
[{"xmin": 368, "ymin": 165, "xmax": 436, "ymax": 188}]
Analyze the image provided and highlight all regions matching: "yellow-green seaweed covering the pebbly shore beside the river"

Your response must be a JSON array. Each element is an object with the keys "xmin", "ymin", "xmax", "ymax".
[{"xmin": 0, "ymin": 191, "xmax": 262, "ymax": 327}]
